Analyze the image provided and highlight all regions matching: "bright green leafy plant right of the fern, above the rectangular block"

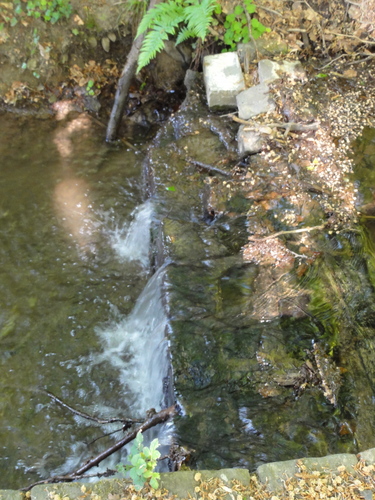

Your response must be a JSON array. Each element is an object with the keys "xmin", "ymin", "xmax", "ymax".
[{"xmin": 219, "ymin": 0, "xmax": 271, "ymax": 52}]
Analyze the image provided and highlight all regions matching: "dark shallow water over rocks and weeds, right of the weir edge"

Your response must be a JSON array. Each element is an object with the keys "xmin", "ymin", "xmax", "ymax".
[{"xmin": 143, "ymin": 80, "xmax": 375, "ymax": 469}]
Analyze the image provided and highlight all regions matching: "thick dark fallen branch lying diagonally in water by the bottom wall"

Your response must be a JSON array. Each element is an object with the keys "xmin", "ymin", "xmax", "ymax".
[{"xmin": 22, "ymin": 405, "xmax": 176, "ymax": 491}]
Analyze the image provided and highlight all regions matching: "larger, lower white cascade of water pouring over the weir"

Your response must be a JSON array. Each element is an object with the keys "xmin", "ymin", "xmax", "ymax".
[{"xmin": 96, "ymin": 268, "xmax": 169, "ymax": 417}]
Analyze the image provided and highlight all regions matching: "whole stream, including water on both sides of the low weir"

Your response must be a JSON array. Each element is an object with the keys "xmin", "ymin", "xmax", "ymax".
[{"xmin": 0, "ymin": 77, "xmax": 375, "ymax": 488}]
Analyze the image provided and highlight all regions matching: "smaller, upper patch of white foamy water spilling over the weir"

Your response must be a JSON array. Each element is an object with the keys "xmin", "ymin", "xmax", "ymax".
[{"xmin": 110, "ymin": 201, "xmax": 153, "ymax": 267}]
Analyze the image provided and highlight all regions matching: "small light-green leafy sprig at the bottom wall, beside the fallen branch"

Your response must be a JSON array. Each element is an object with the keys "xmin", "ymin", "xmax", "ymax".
[{"xmin": 117, "ymin": 431, "xmax": 160, "ymax": 490}]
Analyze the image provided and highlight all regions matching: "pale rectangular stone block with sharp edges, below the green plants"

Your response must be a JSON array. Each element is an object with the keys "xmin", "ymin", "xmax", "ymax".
[{"xmin": 203, "ymin": 52, "xmax": 245, "ymax": 109}]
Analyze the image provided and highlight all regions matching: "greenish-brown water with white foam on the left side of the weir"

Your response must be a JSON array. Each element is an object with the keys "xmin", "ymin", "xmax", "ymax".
[{"xmin": 0, "ymin": 115, "xmax": 166, "ymax": 488}]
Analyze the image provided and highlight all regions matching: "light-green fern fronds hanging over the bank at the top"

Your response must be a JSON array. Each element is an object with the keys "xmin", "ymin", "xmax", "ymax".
[{"xmin": 136, "ymin": 0, "xmax": 217, "ymax": 72}]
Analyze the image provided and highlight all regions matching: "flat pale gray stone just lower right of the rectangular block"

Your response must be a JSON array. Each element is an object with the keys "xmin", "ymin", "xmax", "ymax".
[{"xmin": 237, "ymin": 83, "xmax": 275, "ymax": 120}]
